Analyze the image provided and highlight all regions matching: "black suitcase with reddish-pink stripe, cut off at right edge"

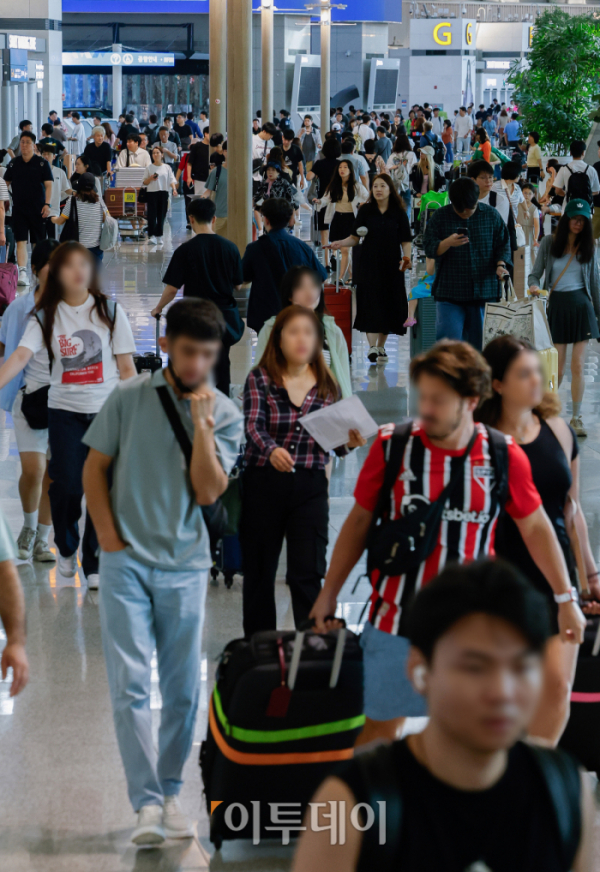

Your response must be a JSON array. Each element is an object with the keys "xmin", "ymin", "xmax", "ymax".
[{"xmin": 559, "ymin": 617, "xmax": 600, "ymax": 777}]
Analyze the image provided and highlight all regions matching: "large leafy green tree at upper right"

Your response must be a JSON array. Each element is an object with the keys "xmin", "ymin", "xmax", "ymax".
[{"xmin": 508, "ymin": 8, "xmax": 600, "ymax": 154}]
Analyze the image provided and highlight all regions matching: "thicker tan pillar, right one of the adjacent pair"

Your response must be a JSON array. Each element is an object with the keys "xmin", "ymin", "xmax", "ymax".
[{"xmin": 226, "ymin": 0, "xmax": 252, "ymax": 255}]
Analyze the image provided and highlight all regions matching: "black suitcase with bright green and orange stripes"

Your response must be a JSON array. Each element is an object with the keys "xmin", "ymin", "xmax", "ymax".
[{"xmin": 200, "ymin": 629, "xmax": 365, "ymax": 849}]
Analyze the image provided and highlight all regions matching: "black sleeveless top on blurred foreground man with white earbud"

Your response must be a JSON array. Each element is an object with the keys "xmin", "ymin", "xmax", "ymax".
[{"xmin": 335, "ymin": 741, "xmax": 576, "ymax": 872}]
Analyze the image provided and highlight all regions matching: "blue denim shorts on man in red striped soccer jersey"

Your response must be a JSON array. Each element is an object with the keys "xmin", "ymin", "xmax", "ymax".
[{"xmin": 360, "ymin": 622, "xmax": 427, "ymax": 721}]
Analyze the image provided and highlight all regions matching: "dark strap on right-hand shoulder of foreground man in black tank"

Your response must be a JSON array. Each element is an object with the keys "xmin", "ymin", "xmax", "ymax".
[{"xmin": 525, "ymin": 744, "xmax": 583, "ymax": 869}]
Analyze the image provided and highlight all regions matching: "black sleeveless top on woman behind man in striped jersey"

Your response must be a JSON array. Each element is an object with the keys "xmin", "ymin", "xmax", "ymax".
[{"xmin": 495, "ymin": 420, "xmax": 579, "ymax": 633}]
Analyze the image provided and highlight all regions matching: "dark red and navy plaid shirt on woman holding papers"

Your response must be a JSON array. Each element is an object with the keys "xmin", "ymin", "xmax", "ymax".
[{"xmin": 244, "ymin": 367, "xmax": 347, "ymax": 469}]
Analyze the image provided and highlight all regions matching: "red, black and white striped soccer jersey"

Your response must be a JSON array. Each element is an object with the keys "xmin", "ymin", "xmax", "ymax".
[{"xmin": 354, "ymin": 422, "xmax": 541, "ymax": 636}]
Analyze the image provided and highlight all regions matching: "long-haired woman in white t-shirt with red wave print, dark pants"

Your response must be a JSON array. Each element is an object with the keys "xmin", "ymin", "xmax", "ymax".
[{"xmin": 0, "ymin": 242, "xmax": 135, "ymax": 589}]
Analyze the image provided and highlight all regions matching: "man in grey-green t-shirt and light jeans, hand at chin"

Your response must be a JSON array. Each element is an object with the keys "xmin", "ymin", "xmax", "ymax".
[{"xmin": 83, "ymin": 297, "xmax": 243, "ymax": 845}]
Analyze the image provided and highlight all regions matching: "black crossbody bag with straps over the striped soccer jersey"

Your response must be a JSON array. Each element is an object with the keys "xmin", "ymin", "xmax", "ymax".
[{"xmin": 367, "ymin": 421, "xmax": 478, "ymax": 577}]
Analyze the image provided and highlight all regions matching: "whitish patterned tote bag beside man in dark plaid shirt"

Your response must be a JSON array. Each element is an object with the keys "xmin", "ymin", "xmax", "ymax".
[{"xmin": 483, "ymin": 279, "xmax": 552, "ymax": 351}]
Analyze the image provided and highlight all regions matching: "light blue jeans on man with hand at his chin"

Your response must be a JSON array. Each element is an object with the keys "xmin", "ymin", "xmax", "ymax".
[{"xmin": 99, "ymin": 549, "xmax": 208, "ymax": 811}]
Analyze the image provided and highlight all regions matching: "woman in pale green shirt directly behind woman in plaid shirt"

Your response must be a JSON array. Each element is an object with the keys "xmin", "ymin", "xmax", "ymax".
[{"xmin": 254, "ymin": 266, "xmax": 352, "ymax": 398}]
